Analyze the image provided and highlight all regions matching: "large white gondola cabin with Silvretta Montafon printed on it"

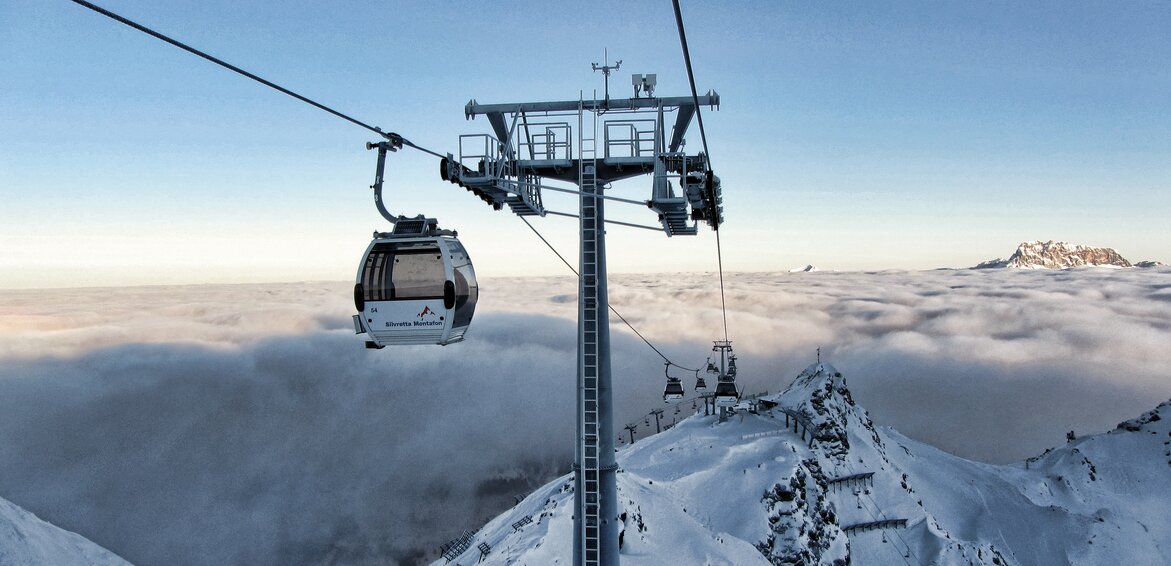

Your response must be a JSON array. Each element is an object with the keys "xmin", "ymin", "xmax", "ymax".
[{"xmin": 354, "ymin": 219, "xmax": 479, "ymax": 348}]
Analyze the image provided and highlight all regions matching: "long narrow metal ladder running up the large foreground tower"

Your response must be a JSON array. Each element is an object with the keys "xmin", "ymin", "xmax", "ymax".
[{"xmin": 577, "ymin": 101, "xmax": 605, "ymax": 566}]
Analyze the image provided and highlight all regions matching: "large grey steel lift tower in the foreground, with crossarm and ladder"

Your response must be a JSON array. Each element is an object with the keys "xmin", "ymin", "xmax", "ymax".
[{"xmin": 440, "ymin": 69, "xmax": 723, "ymax": 566}]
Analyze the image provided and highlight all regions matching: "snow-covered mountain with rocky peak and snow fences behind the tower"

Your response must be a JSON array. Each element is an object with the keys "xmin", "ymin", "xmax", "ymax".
[{"xmin": 436, "ymin": 363, "xmax": 1171, "ymax": 566}]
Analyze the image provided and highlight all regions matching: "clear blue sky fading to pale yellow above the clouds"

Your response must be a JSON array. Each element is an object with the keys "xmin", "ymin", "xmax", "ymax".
[{"xmin": 0, "ymin": 0, "xmax": 1171, "ymax": 287}]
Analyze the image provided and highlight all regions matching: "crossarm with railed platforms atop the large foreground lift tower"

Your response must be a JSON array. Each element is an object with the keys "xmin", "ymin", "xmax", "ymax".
[{"xmin": 443, "ymin": 91, "xmax": 724, "ymax": 236}]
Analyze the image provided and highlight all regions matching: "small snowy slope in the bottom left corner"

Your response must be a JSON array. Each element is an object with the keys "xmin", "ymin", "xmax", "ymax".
[{"xmin": 0, "ymin": 498, "xmax": 130, "ymax": 566}]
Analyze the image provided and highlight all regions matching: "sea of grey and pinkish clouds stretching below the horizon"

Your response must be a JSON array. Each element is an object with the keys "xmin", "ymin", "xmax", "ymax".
[{"xmin": 0, "ymin": 267, "xmax": 1171, "ymax": 565}]
